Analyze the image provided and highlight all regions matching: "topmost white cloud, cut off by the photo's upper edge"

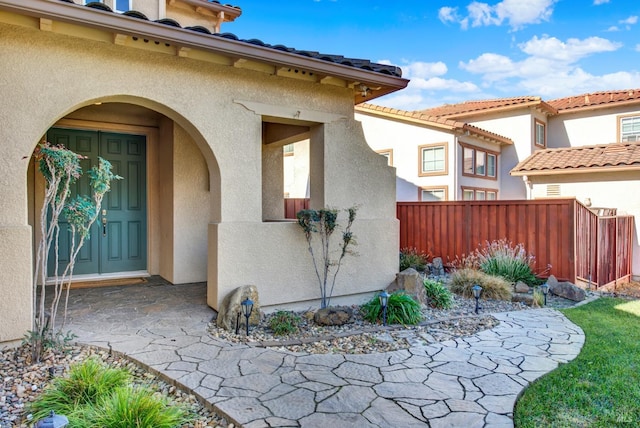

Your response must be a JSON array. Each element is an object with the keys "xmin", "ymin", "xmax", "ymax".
[{"xmin": 438, "ymin": 0, "xmax": 558, "ymax": 30}]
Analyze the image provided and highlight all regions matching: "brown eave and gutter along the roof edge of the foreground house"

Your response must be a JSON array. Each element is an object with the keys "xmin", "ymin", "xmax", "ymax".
[{"xmin": 0, "ymin": 0, "xmax": 409, "ymax": 102}]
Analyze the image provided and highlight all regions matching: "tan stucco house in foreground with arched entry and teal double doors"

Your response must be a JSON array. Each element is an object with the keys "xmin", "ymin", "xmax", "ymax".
[{"xmin": 0, "ymin": 0, "xmax": 407, "ymax": 342}]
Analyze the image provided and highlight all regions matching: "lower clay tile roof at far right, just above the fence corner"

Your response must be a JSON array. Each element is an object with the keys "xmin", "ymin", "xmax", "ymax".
[{"xmin": 511, "ymin": 142, "xmax": 640, "ymax": 175}]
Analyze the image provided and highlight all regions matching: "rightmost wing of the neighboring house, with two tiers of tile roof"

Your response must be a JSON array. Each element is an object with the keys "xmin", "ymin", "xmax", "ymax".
[{"xmin": 511, "ymin": 89, "xmax": 640, "ymax": 279}]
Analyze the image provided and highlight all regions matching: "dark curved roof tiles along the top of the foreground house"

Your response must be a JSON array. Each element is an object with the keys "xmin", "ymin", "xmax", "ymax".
[{"xmin": 69, "ymin": 0, "xmax": 402, "ymax": 77}]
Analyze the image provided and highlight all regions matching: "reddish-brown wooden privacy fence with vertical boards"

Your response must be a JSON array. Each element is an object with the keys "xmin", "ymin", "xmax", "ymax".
[{"xmin": 397, "ymin": 199, "xmax": 633, "ymax": 286}]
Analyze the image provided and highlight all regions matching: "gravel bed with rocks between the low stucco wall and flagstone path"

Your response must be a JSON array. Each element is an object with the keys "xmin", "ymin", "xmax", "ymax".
[{"xmin": 209, "ymin": 295, "xmax": 530, "ymax": 354}]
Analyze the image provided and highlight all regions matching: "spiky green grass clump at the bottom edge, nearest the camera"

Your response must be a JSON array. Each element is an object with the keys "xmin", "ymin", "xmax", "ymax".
[{"xmin": 88, "ymin": 386, "xmax": 188, "ymax": 428}]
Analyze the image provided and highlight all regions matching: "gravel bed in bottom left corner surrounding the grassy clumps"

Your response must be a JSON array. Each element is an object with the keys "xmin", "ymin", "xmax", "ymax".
[{"xmin": 0, "ymin": 346, "xmax": 234, "ymax": 428}]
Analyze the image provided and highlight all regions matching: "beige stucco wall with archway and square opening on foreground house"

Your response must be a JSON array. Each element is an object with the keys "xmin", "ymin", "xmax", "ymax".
[{"xmin": 0, "ymin": 19, "xmax": 398, "ymax": 341}]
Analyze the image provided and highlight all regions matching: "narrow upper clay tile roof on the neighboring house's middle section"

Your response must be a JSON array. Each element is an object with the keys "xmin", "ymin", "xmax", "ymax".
[{"xmin": 422, "ymin": 96, "xmax": 556, "ymax": 118}]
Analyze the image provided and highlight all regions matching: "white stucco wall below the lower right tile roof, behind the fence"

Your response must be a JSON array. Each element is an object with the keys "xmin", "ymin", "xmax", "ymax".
[{"xmin": 531, "ymin": 172, "xmax": 640, "ymax": 279}]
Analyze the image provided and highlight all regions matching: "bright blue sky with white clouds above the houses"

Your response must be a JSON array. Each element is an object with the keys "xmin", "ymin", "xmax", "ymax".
[{"xmin": 222, "ymin": 0, "xmax": 640, "ymax": 110}]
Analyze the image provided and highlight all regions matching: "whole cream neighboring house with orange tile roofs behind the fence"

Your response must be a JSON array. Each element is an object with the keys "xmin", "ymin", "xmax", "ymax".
[{"xmin": 356, "ymin": 89, "xmax": 640, "ymax": 276}]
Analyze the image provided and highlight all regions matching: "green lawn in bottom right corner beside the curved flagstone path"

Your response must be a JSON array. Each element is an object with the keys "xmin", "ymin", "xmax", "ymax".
[{"xmin": 514, "ymin": 298, "xmax": 640, "ymax": 428}]
